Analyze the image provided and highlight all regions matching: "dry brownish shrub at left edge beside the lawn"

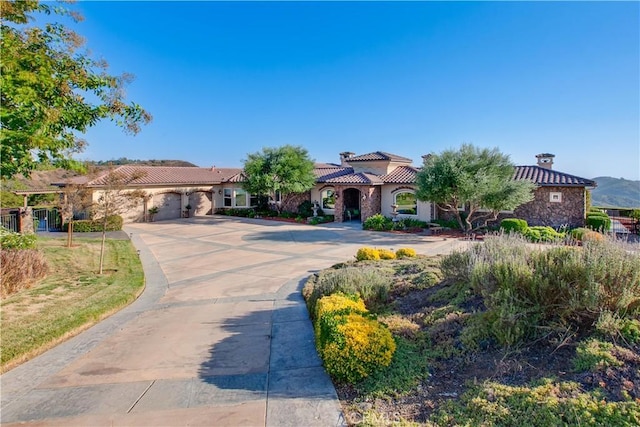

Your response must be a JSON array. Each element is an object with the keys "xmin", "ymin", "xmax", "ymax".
[{"xmin": 0, "ymin": 248, "xmax": 49, "ymax": 298}]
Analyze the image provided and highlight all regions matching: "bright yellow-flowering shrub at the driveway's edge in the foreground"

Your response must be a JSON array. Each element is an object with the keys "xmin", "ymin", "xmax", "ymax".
[{"xmin": 314, "ymin": 294, "xmax": 396, "ymax": 383}]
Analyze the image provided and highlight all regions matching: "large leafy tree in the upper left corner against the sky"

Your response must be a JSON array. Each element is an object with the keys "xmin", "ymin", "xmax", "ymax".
[{"xmin": 0, "ymin": 0, "xmax": 151, "ymax": 178}]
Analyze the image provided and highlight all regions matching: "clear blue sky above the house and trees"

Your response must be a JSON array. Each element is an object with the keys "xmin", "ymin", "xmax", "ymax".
[{"xmin": 63, "ymin": 2, "xmax": 640, "ymax": 179}]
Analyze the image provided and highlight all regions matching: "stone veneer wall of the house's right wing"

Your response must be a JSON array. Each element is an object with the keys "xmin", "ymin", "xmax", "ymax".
[{"xmin": 506, "ymin": 187, "xmax": 585, "ymax": 227}]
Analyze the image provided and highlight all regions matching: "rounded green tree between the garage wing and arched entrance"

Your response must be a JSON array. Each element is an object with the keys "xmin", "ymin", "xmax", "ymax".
[{"xmin": 243, "ymin": 145, "xmax": 315, "ymax": 210}]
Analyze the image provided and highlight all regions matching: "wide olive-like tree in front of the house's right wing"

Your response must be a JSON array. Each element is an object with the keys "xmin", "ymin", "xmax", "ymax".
[{"xmin": 416, "ymin": 144, "xmax": 535, "ymax": 233}]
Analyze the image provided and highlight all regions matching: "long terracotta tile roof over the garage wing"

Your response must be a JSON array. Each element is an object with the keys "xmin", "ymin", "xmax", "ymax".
[{"xmin": 88, "ymin": 165, "xmax": 242, "ymax": 187}]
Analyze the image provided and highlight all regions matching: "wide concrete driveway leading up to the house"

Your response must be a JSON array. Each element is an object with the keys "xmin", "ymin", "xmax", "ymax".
[{"xmin": 0, "ymin": 217, "xmax": 465, "ymax": 426}]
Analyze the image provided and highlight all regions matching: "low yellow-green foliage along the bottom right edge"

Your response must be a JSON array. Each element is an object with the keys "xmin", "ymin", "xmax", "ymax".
[{"xmin": 431, "ymin": 380, "xmax": 640, "ymax": 427}]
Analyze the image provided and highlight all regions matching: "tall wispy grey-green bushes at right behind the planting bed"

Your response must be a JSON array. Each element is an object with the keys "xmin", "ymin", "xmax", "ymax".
[{"xmin": 442, "ymin": 235, "xmax": 640, "ymax": 346}]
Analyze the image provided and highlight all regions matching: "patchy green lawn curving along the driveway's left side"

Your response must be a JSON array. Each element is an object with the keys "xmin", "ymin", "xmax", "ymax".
[{"xmin": 0, "ymin": 238, "xmax": 144, "ymax": 372}]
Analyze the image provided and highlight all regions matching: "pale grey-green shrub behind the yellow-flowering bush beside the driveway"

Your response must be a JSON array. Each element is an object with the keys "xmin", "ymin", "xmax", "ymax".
[{"xmin": 302, "ymin": 267, "xmax": 391, "ymax": 316}]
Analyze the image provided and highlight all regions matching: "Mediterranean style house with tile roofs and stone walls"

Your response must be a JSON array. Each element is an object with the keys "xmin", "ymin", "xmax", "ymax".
[{"xmin": 55, "ymin": 151, "xmax": 596, "ymax": 227}]
